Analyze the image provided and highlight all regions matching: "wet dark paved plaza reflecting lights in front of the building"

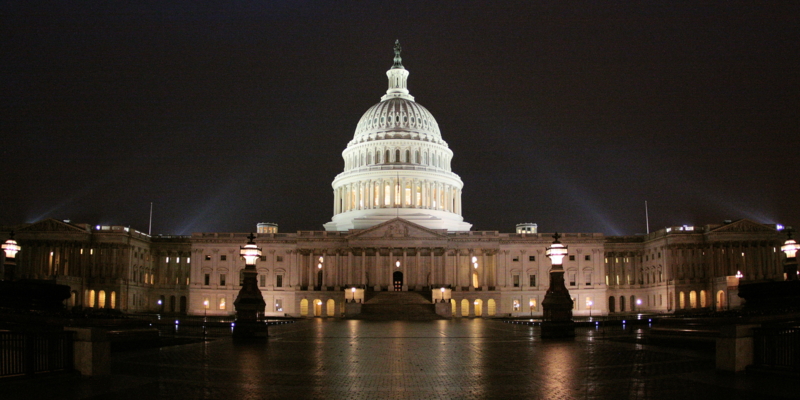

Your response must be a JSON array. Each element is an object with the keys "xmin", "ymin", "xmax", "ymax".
[{"xmin": 0, "ymin": 319, "xmax": 797, "ymax": 400}]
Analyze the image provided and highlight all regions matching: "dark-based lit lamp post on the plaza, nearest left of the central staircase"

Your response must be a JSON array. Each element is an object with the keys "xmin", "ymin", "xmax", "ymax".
[{"xmin": 233, "ymin": 233, "xmax": 267, "ymax": 339}]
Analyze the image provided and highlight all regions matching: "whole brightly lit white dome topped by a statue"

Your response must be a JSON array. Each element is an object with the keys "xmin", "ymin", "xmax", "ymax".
[{"xmin": 324, "ymin": 43, "xmax": 472, "ymax": 231}]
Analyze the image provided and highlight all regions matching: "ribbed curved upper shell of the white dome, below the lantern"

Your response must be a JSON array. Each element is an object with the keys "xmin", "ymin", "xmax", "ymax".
[{"xmin": 353, "ymin": 98, "xmax": 442, "ymax": 143}]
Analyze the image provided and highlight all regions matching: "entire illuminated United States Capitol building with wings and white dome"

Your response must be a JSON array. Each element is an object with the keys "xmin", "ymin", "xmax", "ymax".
[{"xmin": 0, "ymin": 44, "xmax": 785, "ymax": 317}]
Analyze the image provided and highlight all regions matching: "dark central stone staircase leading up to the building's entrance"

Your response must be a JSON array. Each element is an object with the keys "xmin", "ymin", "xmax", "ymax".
[{"xmin": 355, "ymin": 292, "xmax": 443, "ymax": 321}]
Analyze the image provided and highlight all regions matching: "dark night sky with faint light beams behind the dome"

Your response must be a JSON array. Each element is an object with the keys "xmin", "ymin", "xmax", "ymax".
[{"xmin": 0, "ymin": 0, "xmax": 800, "ymax": 235}]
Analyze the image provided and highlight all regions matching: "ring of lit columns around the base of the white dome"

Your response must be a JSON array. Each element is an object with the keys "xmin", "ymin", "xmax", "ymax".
[{"xmin": 333, "ymin": 177, "xmax": 461, "ymax": 215}]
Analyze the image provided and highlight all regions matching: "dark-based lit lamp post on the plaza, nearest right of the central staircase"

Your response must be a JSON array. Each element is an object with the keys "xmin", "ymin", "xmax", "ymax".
[{"xmin": 542, "ymin": 232, "xmax": 575, "ymax": 338}]
